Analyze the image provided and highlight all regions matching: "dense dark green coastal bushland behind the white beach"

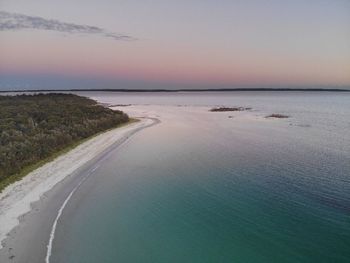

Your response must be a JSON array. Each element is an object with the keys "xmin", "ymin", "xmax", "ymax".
[{"xmin": 0, "ymin": 93, "xmax": 129, "ymax": 191}]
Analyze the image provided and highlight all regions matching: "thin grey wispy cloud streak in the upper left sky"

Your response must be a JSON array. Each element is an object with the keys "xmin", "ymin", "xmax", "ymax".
[{"xmin": 0, "ymin": 11, "xmax": 136, "ymax": 41}]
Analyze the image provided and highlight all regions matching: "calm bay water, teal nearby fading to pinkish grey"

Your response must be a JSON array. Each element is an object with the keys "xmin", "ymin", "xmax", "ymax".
[{"xmin": 52, "ymin": 92, "xmax": 350, "ymax": 263}]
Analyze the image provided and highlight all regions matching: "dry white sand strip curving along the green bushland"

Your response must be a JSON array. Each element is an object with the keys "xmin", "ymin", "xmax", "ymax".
[{"xmin": 0, "ymin": 118, "xmax": 159, "ymax": 252}]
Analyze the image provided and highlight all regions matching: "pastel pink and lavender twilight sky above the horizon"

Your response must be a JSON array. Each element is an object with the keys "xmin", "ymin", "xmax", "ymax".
[{"xmin": 0, "ymin": 0, "xmax": 350, "ymax": 90}]
